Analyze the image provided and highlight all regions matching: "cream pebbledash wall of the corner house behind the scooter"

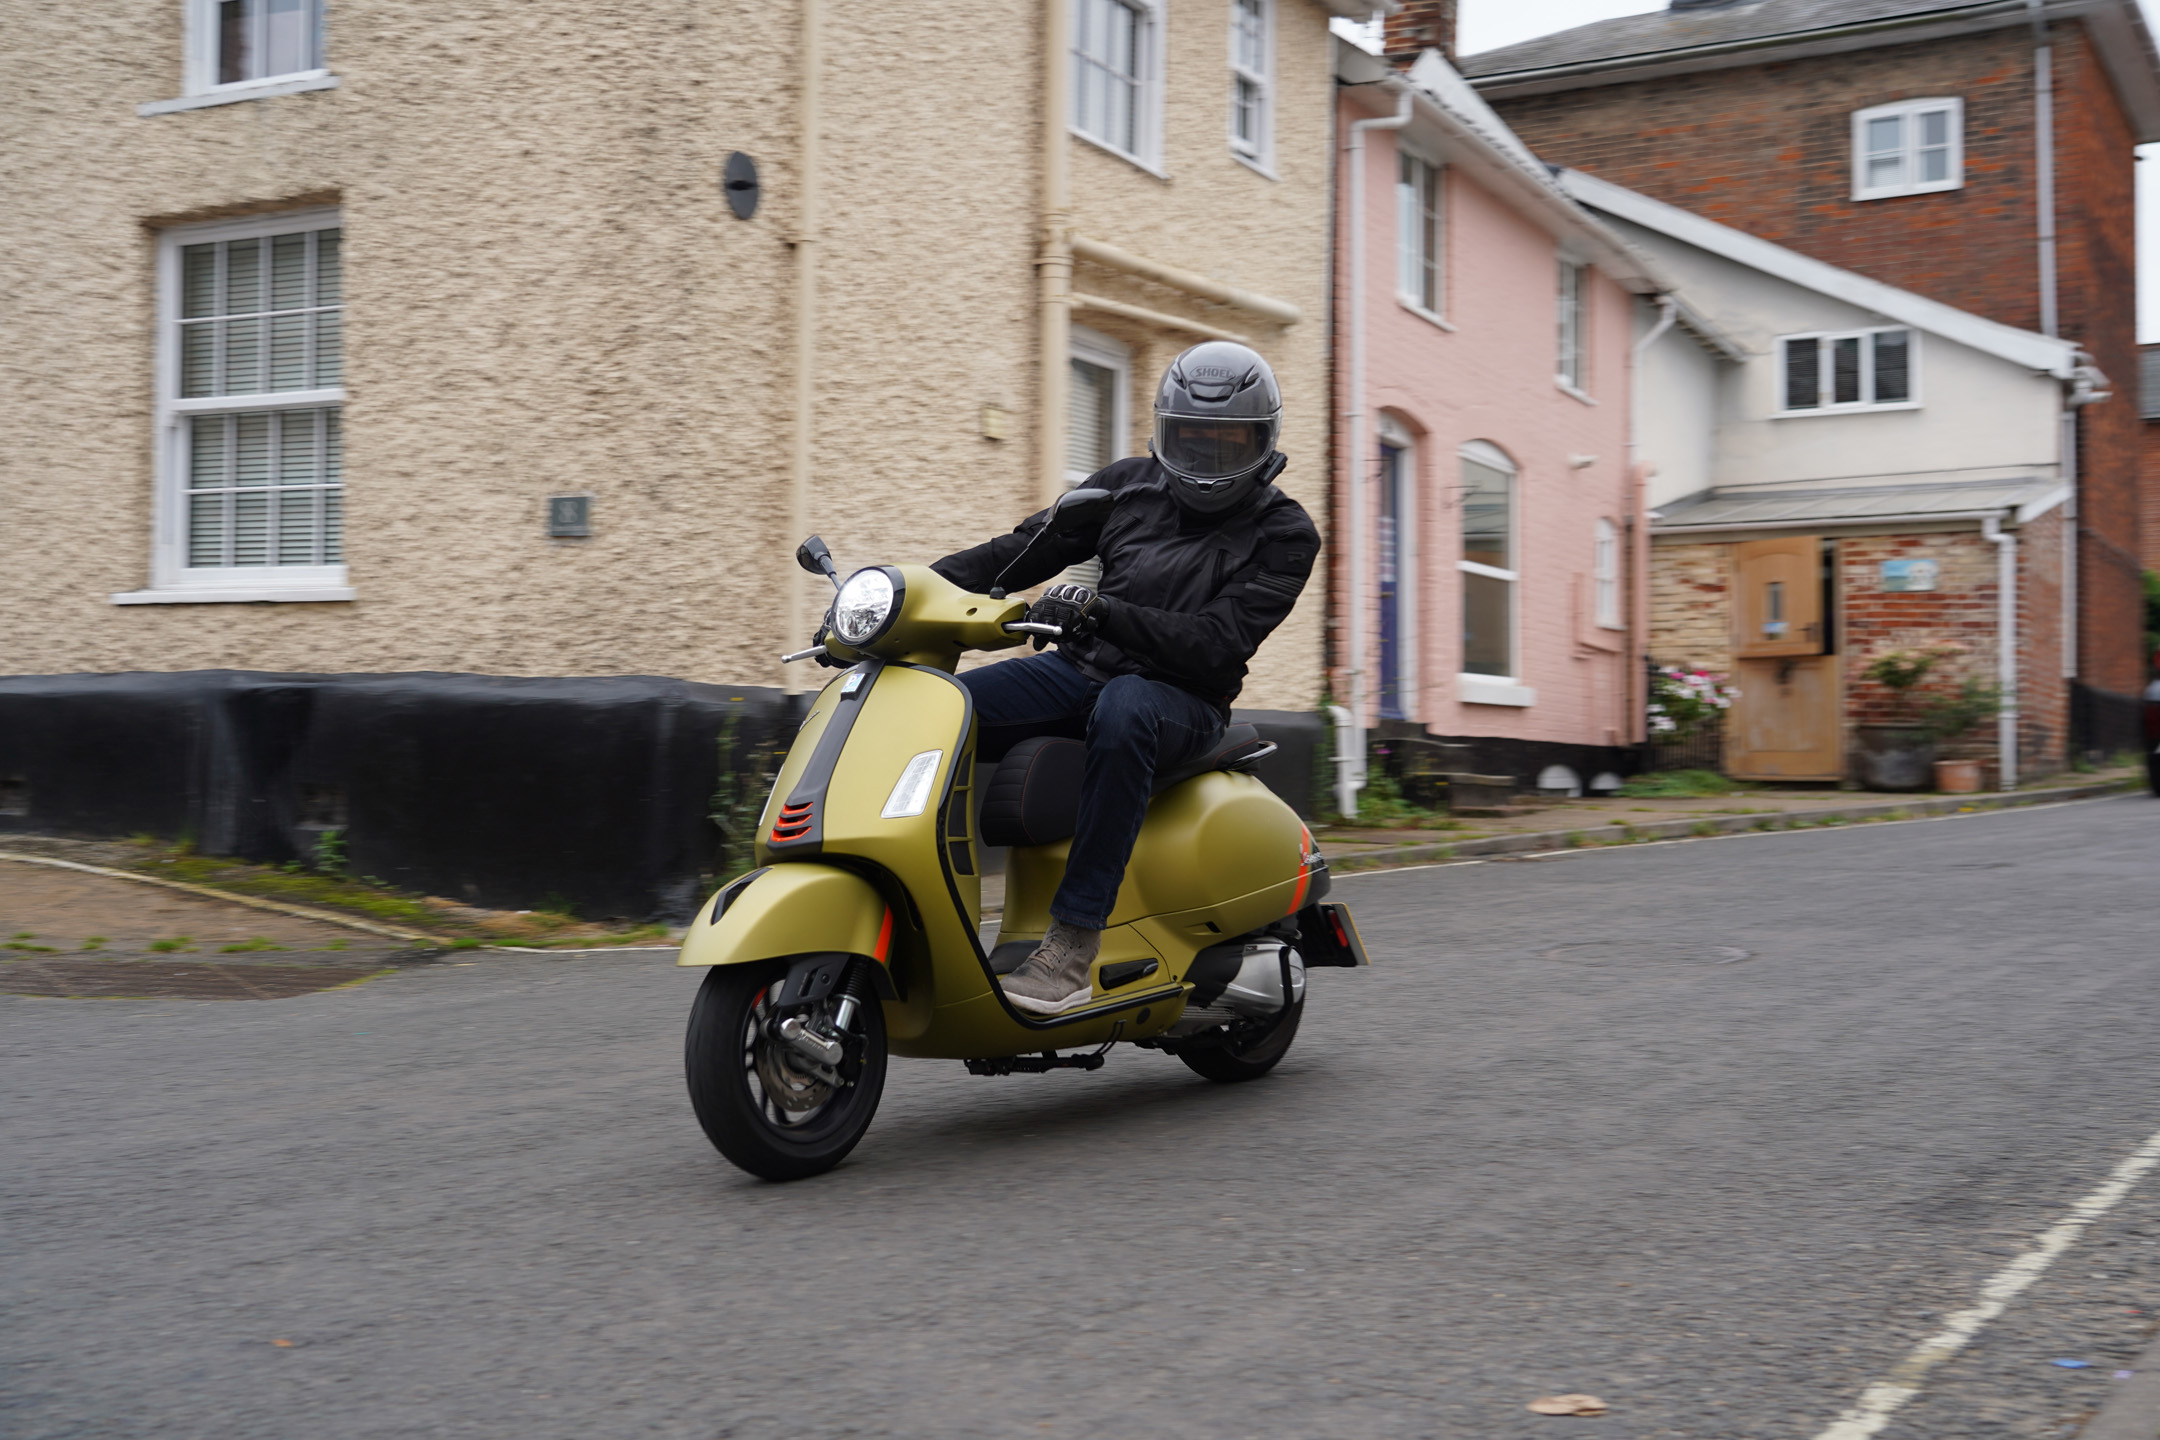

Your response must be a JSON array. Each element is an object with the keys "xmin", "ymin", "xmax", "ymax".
[{"xmin": 0, "ymin": 0, "xmax": 1335, "ymax": 913}]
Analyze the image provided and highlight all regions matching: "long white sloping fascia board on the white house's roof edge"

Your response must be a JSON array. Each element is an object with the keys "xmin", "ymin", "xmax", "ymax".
[{"xmin": 1560, "ymin": 171, "xmax": 2078, "ymax": 380}]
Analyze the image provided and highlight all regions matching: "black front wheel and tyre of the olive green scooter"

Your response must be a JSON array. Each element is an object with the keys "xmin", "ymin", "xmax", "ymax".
[{"xmin": 683, "ymin": 965, "xmax": 886, "ymax": 1181}]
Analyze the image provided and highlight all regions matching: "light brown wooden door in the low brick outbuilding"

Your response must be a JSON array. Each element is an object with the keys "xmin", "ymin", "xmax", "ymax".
[{"xmin": 1726, "ymin": 535, "xmax": 1845, "ymax": 779}]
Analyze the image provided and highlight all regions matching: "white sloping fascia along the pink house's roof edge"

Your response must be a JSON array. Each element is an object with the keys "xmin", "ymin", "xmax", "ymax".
[{"xmin": 1367, "ymin": 50, "xmax": 1672, "ymax": 294}]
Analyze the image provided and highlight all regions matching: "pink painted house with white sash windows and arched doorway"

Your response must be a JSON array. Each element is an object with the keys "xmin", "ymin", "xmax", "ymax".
[{"xmin": 1331, "ymin": 43, "xmax": 1665, "ymax": 814}]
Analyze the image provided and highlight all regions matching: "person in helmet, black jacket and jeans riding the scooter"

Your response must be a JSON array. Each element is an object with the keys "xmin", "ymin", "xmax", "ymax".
[{"xmin": 931, "ymin": 341, "xmax": 1320, "ymax": 1015}]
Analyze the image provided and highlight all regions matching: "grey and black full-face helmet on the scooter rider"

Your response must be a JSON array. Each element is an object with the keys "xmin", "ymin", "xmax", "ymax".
[{"xmin": 1149, "ymin": 339, "xmax": 1283, "ymax": 516}]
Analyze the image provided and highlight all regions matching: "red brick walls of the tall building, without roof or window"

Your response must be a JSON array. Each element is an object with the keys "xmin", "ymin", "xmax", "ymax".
[{"xmin": 1495, "ymin": 22, "xmax": 2160, "ymax": 693}]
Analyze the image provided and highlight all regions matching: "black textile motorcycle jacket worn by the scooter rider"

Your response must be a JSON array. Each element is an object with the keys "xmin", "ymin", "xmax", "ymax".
[{"xmin": 931, "ymin": 456, "xmax": 1320, "ymax": 719}]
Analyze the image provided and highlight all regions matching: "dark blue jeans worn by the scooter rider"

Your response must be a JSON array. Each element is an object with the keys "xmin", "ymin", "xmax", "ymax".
[{"xmin": 959, "ymin": 650, "xmax": 1223, "ymax": 930}]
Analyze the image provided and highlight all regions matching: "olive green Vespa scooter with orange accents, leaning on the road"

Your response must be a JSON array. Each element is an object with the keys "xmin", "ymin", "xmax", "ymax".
[{"xmin": 676, "ymin": 490, "xmax": 1367, "ymax": 1179}]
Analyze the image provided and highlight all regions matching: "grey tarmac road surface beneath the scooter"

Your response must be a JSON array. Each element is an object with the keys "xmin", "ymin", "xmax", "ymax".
[{"xmin": 0, "ymin": 797, "xmax": 2160, "ymax": 1440}]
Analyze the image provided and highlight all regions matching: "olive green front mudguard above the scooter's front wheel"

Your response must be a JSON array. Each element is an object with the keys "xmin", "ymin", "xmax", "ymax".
[{"xmin": 676, "ymin": 859, "xmax": 892, "ymax": 975}]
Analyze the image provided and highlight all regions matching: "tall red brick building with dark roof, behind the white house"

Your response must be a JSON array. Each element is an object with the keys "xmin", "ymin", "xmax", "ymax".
[{"xmin": 1451, "ymin": 0, "xmax": 2160, "ymax": 745}]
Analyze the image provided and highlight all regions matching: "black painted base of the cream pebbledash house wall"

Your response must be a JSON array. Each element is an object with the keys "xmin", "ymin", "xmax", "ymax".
[{"xmin": 0, "ymin": 669, "xmax": 1320, "ymax": 922}]
